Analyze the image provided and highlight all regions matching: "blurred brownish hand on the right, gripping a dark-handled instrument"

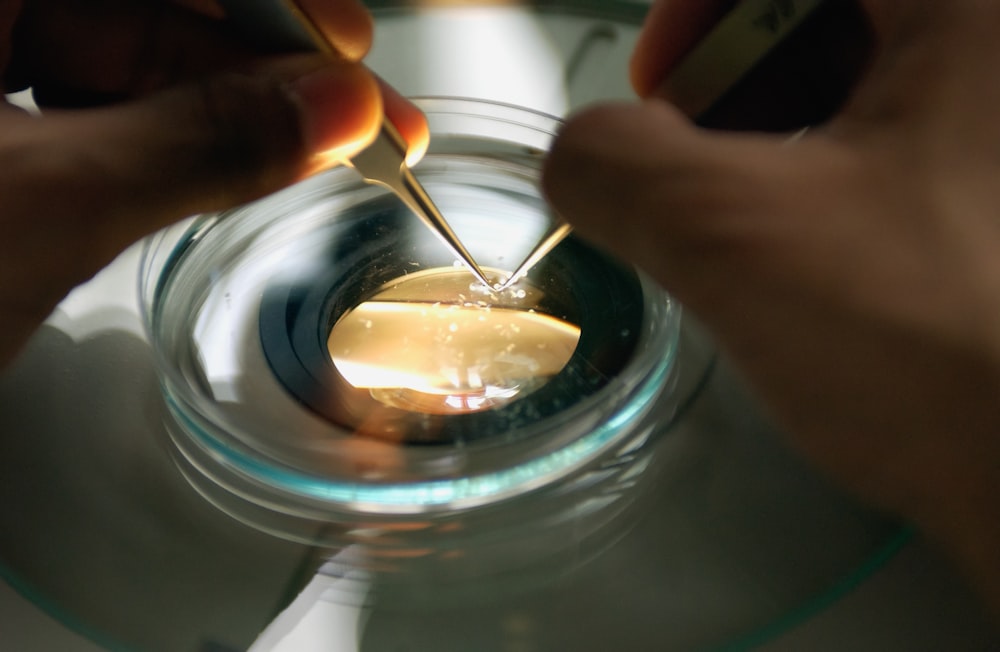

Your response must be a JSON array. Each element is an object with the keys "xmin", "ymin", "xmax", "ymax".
[{"xmin": 544, "ymin": 0, "xmax": 1000, "ymax": 611}]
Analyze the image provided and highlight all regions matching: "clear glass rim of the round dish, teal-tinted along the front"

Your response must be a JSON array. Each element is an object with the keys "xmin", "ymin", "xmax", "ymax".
[{"xmin": 138, "ymin": 96, "xmax": 680, "ymax": 511}]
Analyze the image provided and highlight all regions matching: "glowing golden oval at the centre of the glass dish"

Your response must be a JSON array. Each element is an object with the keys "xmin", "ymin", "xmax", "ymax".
[{"xmin": 327, "ymin": 268, "xmax": 580, "ymax": 414}]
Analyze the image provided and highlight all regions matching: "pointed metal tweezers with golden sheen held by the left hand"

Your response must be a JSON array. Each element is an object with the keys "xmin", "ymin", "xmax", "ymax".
[{"xmin": 221, "ymin": 0, "xmax": 493, "ymax": 287}]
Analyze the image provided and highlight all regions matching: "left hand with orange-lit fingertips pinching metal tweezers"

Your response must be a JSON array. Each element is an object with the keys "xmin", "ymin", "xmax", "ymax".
[{"xmin": 0, "ymin": 0, "xmax": 427, "ymax": 367}]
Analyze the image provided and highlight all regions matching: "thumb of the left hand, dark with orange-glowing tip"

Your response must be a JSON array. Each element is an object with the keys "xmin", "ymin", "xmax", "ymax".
[{"xmin": 0, "ymin": 57, "xmax": 381, "ymax": 365}]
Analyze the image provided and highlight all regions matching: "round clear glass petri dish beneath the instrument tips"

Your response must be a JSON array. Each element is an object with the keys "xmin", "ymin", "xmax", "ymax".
[{"xmin": 140, "ymin": 98, "xmax": 707, "ymax": 582}]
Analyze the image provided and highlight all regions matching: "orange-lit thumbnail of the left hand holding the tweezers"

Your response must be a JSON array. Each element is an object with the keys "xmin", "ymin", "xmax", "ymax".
[{"xmin": 289, "ymin": 61, "xmax": 382, "ymax": 160}]
